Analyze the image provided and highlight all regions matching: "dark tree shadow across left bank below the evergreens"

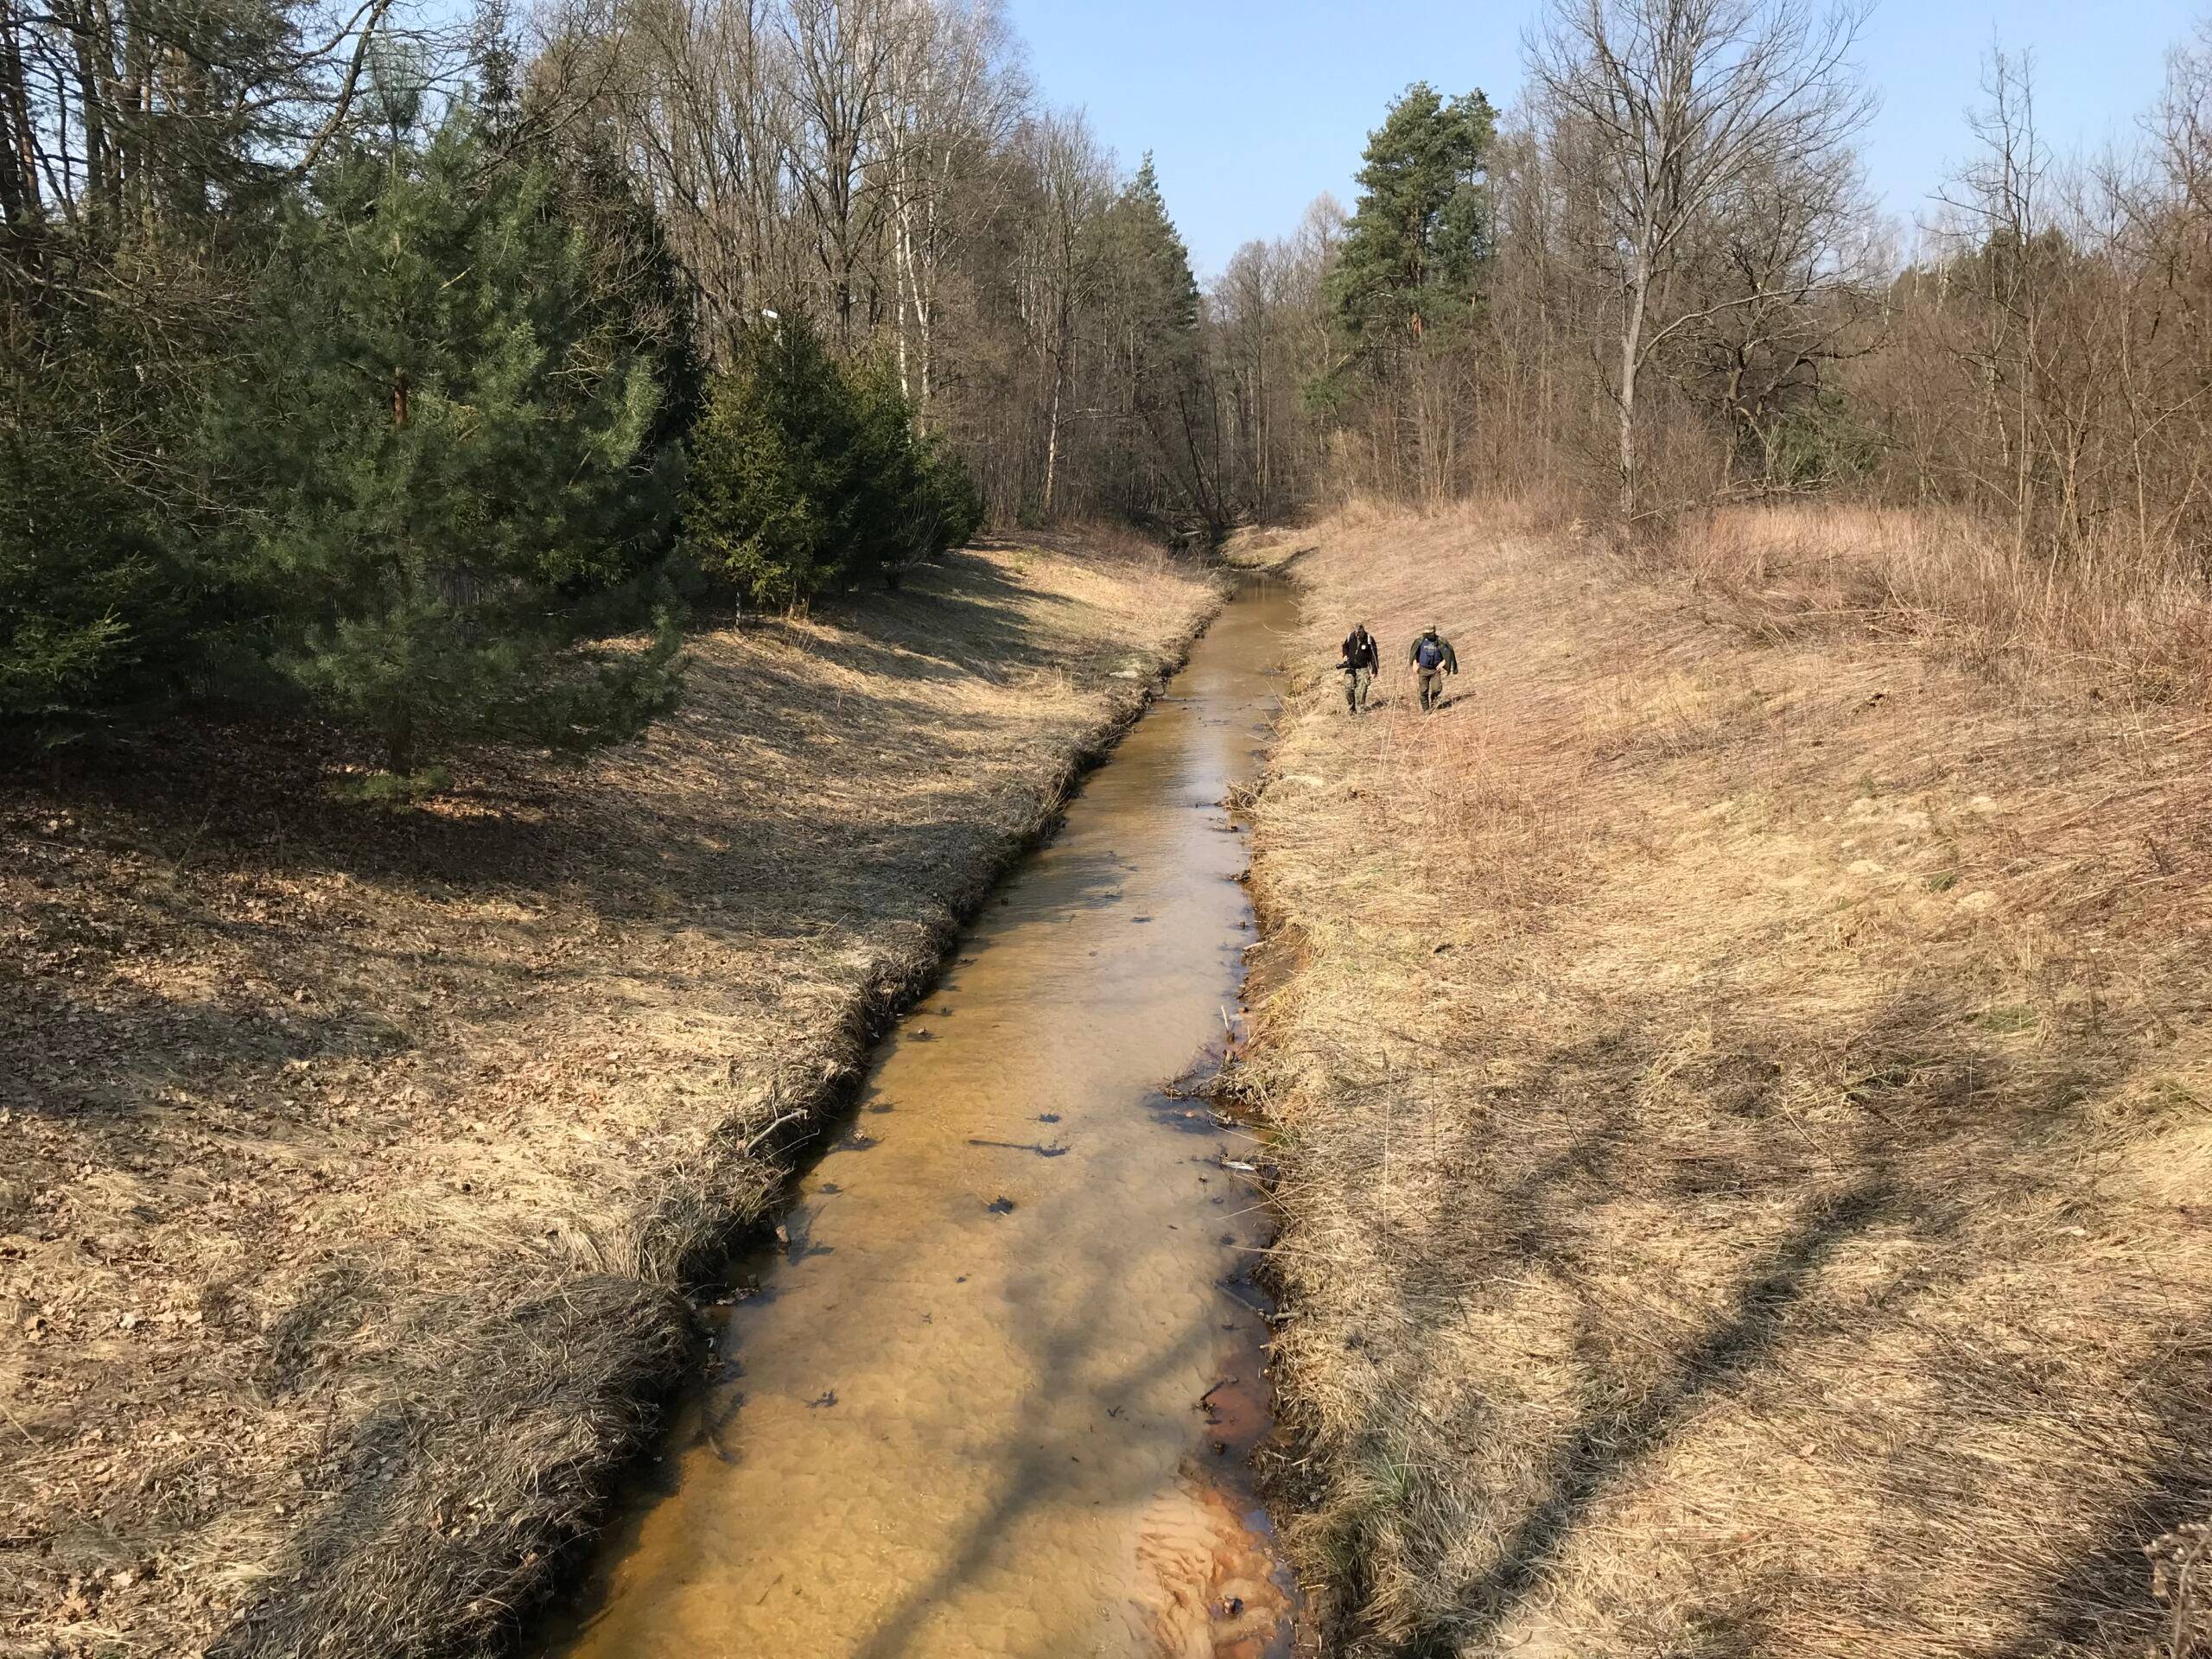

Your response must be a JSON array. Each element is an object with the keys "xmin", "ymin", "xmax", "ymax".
[{"xmin": 0, "ymin": 556, "xmax": 1176, "ymax": 1117}]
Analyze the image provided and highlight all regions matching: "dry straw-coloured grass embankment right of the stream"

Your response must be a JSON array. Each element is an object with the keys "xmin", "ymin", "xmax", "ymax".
[{"xmin": 1252, "ymin": 513, "xmax": 2212, "ymax": 1659}]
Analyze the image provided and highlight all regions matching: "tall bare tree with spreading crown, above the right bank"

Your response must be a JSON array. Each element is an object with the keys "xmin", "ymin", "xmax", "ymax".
[{"xmin": 1526, "ymin": 0, "xmax": 1873, "ymax": 518}]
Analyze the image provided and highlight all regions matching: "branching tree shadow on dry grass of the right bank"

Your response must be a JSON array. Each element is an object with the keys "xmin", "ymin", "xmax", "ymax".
[{"xmin": 1292, "ymin": 976, "xmax": 2212, "ymax": 1659}]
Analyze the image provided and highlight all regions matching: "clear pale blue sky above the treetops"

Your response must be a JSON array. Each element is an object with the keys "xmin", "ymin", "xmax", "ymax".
[{"xmin": 1011, "ymin": 0, "xmax": 2212, "ymax": 279}]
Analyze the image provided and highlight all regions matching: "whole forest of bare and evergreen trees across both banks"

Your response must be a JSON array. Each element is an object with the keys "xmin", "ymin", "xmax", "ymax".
[{"xmin": 17, "ymin": 0, "xmax": 2212, "ymax": 779}]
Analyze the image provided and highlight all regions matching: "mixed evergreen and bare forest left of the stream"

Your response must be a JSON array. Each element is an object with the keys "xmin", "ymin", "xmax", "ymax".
[{"xmin": 0, "ymin": 0, "xmax": 1228, "ymax": 791}]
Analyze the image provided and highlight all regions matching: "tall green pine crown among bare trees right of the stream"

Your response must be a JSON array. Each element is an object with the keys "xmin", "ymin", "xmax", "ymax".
[{"xmin": 1330, "ymin": 82, "xmax": 1497, "ymax": 343}]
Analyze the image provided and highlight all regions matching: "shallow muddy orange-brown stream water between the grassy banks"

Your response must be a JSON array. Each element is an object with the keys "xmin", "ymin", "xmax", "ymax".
[{"xmin": 556, "ymin": 580, "xmax": 1294, "ymax": 1659}]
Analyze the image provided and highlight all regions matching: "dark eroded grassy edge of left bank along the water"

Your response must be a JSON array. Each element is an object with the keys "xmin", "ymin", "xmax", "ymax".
[{"xmin": 208, "ymin": 577, "xmax": 1230, "ymax": 1659}]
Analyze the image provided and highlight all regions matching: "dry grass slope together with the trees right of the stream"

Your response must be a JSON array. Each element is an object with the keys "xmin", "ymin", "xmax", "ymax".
[{"xmin": 1219, "ymin": 0, "xmax": 2212, "ymax": 1659}]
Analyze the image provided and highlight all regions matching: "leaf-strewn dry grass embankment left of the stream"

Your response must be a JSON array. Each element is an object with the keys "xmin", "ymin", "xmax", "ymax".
[{"xmin": 0, "ymin": 546, "xmax": 1212, "ymax": 1655}]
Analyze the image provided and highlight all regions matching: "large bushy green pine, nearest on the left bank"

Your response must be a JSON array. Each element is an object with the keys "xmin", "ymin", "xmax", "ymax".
[{"xmin": 232, "ymin": 108, "xmax": 681, "ymax": 772}]
